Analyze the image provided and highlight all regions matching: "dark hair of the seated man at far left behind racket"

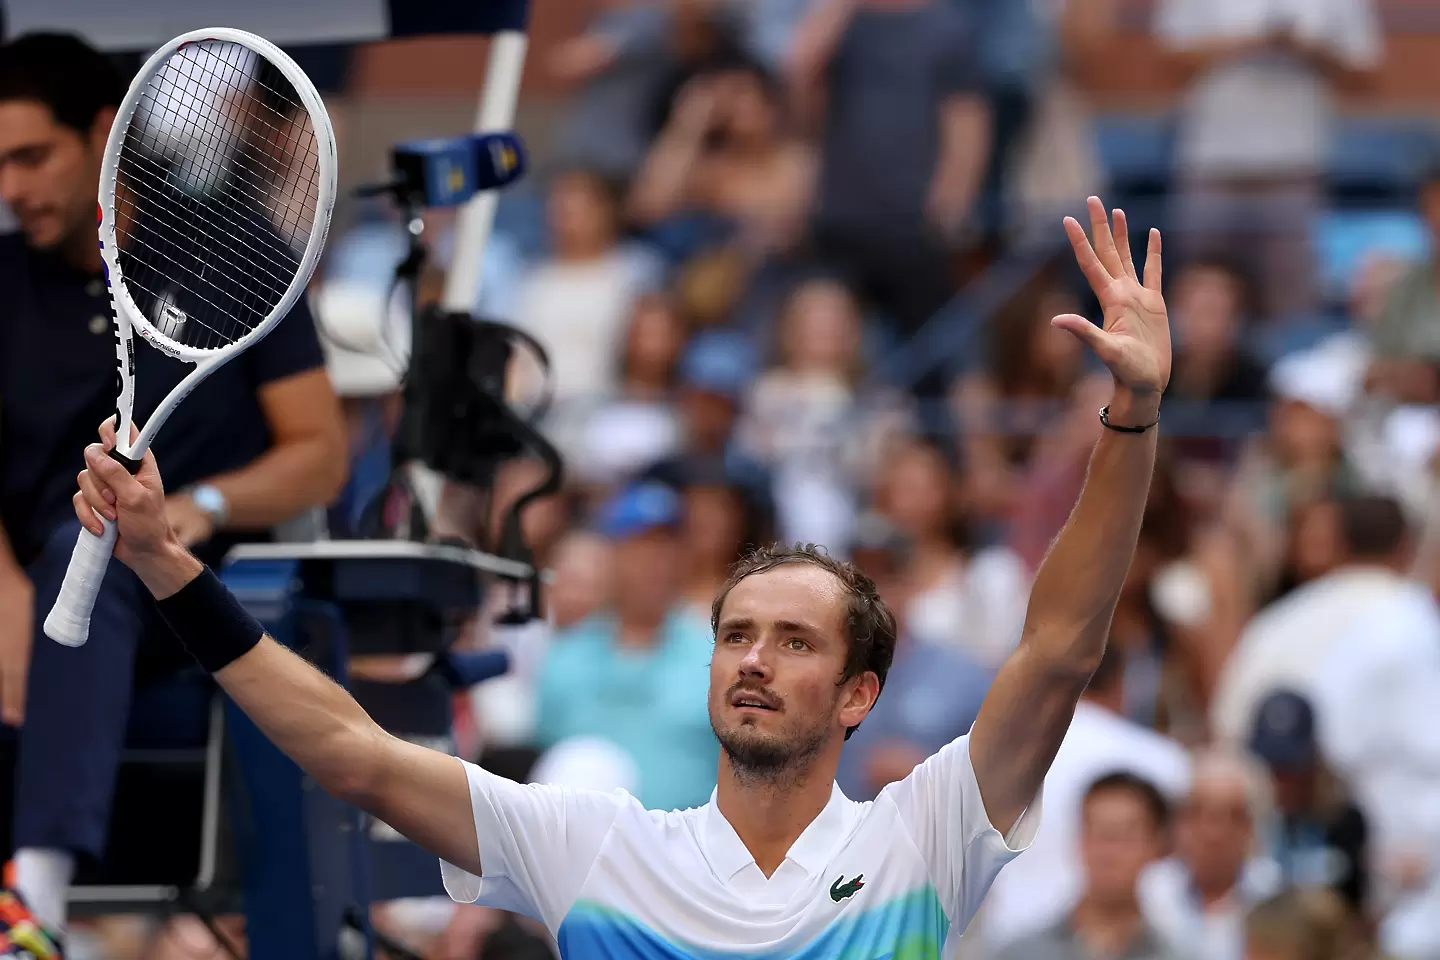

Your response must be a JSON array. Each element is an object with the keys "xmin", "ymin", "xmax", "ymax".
[{"xmin": 0, "ymin": 33, "xmax": 125, "ymax": 134}]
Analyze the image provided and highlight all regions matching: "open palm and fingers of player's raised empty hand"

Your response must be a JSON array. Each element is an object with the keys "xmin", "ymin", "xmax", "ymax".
[{"xmin": 1051, "ymin": 197, "xmax": 1171, "ymax": 394}]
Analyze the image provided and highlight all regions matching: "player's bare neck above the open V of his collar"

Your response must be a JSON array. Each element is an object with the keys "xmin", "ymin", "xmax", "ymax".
[{"xmin": 716, "ymin": 753, "xmax": 838, "ymax": 877}]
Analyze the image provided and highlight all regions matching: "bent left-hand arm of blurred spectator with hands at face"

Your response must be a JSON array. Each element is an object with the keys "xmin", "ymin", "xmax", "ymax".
[{"xmin": 629, "ymin": 75, "xmax": 720, "ymax": 226}]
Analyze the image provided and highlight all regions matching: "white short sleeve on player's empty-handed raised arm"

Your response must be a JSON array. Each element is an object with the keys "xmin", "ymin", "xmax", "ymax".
[{"xmin": 880, "ymin": 735, "xmax": 1040, "ymax": 928}]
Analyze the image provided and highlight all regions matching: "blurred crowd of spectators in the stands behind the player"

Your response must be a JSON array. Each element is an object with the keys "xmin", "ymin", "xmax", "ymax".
[{"xmin": 8, "ymin": 0, "xmax": 1440, "ymax": 960}]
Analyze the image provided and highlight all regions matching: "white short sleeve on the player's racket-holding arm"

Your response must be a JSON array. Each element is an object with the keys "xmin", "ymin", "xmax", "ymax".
[{"xmin": 441, "ymin": 760, "xmax": 634, "ymax": 934}]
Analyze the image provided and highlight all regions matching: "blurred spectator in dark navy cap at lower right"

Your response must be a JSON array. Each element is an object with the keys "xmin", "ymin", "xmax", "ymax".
[{"xmin": 1250, "ymin": 689, "xmax": 1369, "ymax": 917}]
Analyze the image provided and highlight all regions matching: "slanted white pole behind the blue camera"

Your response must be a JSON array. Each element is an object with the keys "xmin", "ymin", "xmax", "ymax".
[{"xmin": 442, "ymin": 30, "xmax": 527, "ymax": 314}]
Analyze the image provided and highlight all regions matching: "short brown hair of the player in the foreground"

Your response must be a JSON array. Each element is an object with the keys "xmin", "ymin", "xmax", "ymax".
[{"xmin": 710, "ymin": 544, "xmax": 896, "ymax": 740}]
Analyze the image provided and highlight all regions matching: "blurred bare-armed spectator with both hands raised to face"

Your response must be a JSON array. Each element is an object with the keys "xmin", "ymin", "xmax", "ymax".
[{"xmin": 629, "ymin": 65, "xmax": 814, "ymax": 258}]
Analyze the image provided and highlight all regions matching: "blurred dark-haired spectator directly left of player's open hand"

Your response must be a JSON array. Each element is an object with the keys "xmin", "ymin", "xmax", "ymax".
[{"xmin": 955, "ymin": 270, "xmax": 1089, "ymax": 526}]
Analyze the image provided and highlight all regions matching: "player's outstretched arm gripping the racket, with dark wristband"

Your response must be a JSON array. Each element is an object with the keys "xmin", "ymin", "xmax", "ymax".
[{"xmin": 75, "ymin": 425, "xmax": 480, "ymax": 875}]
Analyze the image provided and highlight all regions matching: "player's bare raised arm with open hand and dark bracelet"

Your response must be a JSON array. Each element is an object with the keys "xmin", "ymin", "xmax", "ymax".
[{"xmin": 971, "ymin": 197, "xmax": 1171, "ymax": 833}]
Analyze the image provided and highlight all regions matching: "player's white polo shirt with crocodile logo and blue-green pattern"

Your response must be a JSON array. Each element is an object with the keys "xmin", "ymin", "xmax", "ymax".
[{"xmin": 441, "ymin": 737, "xmax": 1040, "ymax": 960}]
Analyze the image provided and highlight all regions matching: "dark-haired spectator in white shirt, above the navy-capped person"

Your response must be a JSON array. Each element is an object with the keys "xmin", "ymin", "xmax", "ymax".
[{"xmin": 1210, "ymin": 497, "xmax": 1417, "ymax": 744}]
